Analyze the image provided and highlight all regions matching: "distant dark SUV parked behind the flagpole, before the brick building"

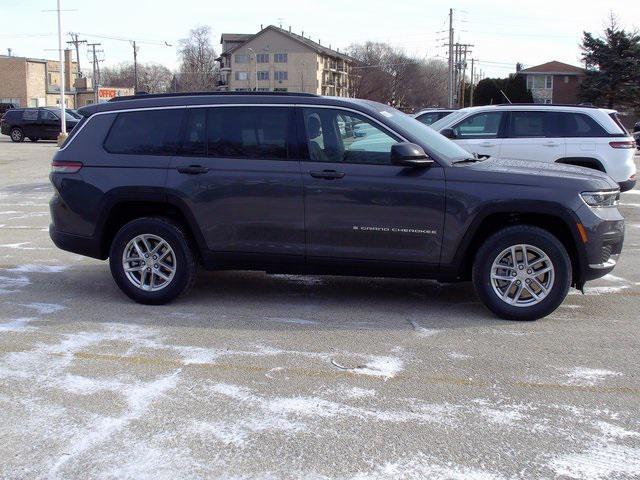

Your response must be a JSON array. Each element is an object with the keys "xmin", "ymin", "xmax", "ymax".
[{"xmin": 0, "ymin": 107, "xmax": 80, "ymax": 142}]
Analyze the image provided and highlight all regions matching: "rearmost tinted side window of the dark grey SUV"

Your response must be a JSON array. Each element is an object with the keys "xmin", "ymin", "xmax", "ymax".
[{"xmin": 104, "ymin": 109, "xmax": 184, "ymax": 155}]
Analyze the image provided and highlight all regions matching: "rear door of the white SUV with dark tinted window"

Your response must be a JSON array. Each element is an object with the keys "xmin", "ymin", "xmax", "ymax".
[{"xmin": 500, "ymin": 110, "xmax": 566, "ymax": 163}]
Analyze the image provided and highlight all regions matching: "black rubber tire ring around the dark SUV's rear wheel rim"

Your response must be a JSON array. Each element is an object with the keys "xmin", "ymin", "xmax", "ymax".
[{"xmin": 109, "ymin": 217, "xmax": 197, "ymax": 305}]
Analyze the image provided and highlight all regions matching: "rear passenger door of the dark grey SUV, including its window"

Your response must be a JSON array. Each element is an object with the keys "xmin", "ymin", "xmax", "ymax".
[{"xmin": 168, "ymin": 105, "xmax": 305, "ymax": 263}]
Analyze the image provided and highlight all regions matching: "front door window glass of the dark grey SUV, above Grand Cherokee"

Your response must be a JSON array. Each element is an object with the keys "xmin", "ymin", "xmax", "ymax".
[{"xmin": 303, "ymin": 108, "xmax": 399, "ymax": 165}]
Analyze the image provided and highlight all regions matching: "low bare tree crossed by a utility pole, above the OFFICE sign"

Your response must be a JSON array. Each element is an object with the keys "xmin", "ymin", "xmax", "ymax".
[{"xmin": 100, "ymin": 63, "xmax": 173, "ymax": 93}]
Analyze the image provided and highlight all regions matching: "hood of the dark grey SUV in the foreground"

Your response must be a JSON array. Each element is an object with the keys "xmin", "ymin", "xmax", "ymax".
[{"xmin": 467, "ymin": 158, "xmax": 618, "ymax": 190}]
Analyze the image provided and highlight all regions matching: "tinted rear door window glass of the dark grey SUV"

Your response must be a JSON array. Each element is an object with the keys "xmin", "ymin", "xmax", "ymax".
[{"xmin": 207, "ymin": 107, "xmax": 290, "ymax": 160}]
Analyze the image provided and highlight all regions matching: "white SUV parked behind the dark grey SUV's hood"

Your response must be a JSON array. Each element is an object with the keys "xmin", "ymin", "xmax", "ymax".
[{"xmin": 431, "ymin": 104, "xmax": 636, "ymax": 192}]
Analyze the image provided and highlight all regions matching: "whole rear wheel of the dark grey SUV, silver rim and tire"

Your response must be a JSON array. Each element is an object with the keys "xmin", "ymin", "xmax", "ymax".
[{"xmin": 109, "ymin": 217, "xmax": 196, "ymax": 305}]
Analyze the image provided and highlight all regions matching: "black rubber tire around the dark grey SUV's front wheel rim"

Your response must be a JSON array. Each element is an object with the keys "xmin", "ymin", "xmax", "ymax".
[{"xmin": 473, "ymin": 225, "xmax": 572, "ymax": 321}]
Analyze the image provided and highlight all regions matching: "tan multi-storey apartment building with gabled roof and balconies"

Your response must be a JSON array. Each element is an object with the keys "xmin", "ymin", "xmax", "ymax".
[{"xmin": 218, "ymin": 25, "xmax": 353, "ymax": 97}]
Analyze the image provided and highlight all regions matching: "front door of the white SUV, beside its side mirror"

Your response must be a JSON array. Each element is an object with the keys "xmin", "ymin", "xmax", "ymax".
[{"xmin": 452, "ymin": 111, "xmax": 504, "ymax": 157}]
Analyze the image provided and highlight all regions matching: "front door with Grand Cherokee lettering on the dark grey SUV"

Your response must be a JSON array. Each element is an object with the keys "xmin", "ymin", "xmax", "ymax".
[{"xmin": 300, "ymin": 107, "xmax": 445, "ymax": 266}]
